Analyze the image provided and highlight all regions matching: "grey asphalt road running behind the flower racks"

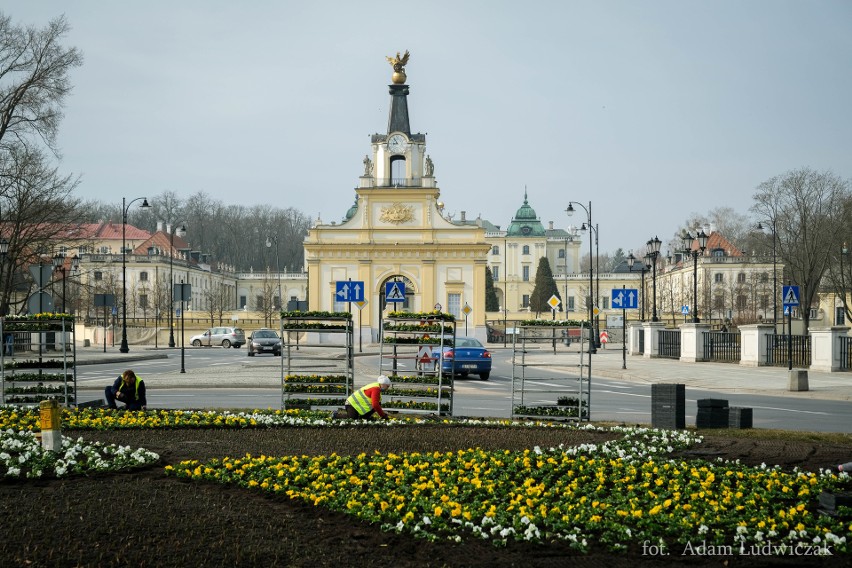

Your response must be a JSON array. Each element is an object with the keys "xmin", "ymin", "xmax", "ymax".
[{"xmin": 77, "ymin": 348, "xmax": 852, "ymax": 432}]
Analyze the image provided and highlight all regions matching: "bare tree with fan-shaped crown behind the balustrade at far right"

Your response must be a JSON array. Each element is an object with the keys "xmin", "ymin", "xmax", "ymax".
[{"xmin": 752, "ymin": 168, "xmax": 850, "ymax": 327}]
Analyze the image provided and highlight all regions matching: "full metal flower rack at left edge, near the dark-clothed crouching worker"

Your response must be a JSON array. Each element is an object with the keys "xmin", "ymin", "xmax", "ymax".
[{"xmin": 0, "ymin": 315, "xmax": 77, "ymax": 407}]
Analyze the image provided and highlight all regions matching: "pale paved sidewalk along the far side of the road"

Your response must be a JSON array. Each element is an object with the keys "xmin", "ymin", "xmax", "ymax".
[{"xmin": 68, "ymin": 344, "xmax": 852, "ymax": 401}]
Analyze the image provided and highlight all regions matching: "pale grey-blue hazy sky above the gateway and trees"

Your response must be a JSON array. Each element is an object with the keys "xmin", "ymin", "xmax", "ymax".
[{"xmin": 6, "ymin": 0, "xmax": 852, "ymax": 253}]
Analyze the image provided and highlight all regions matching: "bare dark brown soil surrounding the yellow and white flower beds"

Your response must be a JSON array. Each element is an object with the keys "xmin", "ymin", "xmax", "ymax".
[{"xmin": 0, "ymin": 426, "xmax": 852, "ymax": 568}]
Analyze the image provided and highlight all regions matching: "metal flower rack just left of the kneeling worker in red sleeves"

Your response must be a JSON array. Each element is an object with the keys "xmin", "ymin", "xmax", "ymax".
[{"xmin": 281, "ymin": 312, "xmax": 355, "ymax": 410}]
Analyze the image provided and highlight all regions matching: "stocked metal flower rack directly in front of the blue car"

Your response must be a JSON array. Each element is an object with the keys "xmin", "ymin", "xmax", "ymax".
[{"xmin": 379, "ymin": 312, "xmax": 456, "ymax": 416}]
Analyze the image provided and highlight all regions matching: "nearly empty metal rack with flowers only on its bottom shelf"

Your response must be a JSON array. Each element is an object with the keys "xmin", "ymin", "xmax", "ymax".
[{"xmin": 512, "ymin": 324, "xmax": 591, "ymax": 422}]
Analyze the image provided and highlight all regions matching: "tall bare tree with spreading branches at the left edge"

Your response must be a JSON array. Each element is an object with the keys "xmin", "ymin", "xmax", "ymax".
[{"xmin": 0, "ymin": 13, "xmax": 83, "ymax": 313}]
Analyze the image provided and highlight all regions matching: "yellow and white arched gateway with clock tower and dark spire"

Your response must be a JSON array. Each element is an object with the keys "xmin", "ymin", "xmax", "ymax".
[{"xmin": 304, "ymin": 53, "xmax": 490, "ymax": 341}]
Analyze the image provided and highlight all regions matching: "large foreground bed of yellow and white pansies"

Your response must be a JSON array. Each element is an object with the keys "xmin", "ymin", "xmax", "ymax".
[{"xmin": 166, "ymin": 428, "xmax": 850, "ymax": 554}]
